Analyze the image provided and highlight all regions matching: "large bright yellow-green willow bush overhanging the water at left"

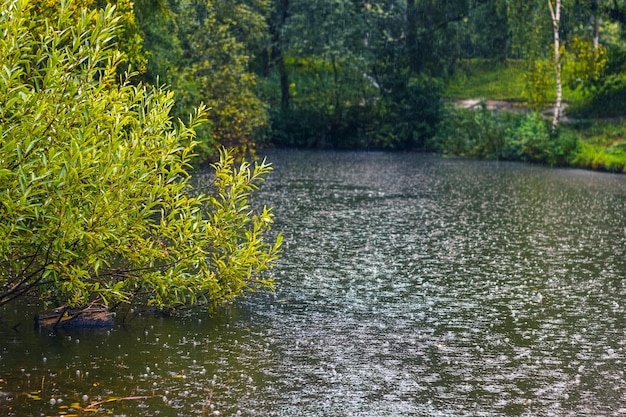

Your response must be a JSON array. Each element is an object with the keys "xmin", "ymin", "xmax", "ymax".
[{"xmin": 0, "ymin": 0, "xmax": 280, "ymax": 309}]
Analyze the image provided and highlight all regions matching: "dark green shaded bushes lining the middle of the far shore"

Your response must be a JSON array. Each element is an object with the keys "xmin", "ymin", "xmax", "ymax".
[{"xmin": 268, "ymin": 61, "xmax": 442, "ymax": 150}]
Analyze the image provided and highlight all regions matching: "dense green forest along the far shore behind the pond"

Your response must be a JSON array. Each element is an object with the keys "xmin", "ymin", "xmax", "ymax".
[{"xmin": 31, "ymin": 0, "xmax": 626, "ymax": 167}]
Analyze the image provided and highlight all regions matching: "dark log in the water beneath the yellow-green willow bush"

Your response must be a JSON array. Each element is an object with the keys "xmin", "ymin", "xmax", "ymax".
[{"xmin": 35, "ymin": 306, "xmax": 113, "ymax": 328}]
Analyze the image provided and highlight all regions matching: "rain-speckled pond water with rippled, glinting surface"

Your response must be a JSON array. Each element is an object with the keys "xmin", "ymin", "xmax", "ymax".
[{"xmin": 0, "ymin": 151, "xmax": 626, "ymax": 417}]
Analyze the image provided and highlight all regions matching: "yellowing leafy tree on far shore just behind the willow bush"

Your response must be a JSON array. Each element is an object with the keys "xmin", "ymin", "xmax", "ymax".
[{"xmin": 176, "ymin": 0, "xmax": 267, "ymax": 154}]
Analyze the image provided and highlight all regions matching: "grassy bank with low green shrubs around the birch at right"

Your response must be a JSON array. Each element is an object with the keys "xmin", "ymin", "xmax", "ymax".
[{"xmin": 438, "ymin": 60, "xmax": 626, "ymax": 173}]
